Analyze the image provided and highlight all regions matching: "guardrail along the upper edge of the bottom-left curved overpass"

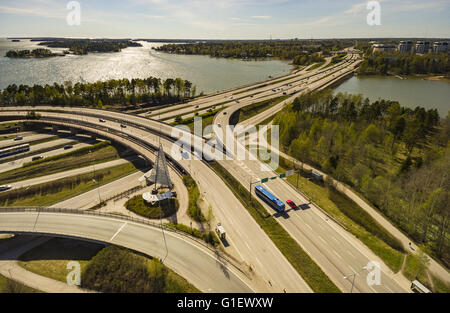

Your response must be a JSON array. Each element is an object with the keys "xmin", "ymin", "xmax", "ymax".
[{"xmin": 0, "ymin": 207, "xmax": 248, "ymax": 277}]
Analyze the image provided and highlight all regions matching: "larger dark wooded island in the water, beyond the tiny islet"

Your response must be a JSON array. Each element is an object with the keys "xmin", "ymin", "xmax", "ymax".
[{"xmin": 39, "ymin": 39, "xmax": 142, "ymax": 55}]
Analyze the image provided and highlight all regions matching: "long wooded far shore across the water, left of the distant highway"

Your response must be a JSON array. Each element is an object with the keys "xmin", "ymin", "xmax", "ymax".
[{"xmin": 156, "ymin": 40, "xmax": 352, "ymax": 65}]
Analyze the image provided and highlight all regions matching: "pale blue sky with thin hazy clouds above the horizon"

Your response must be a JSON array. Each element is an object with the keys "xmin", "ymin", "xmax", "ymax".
[{"xmin": 0, "ymin": 0, "xmax": 450, "ymax": 39}]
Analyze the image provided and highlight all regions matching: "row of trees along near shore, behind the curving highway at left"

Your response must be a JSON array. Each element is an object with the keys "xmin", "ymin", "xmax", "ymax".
[{"xmin": 0, "ymin": 77, "xmax": 196, "ymax": 107}]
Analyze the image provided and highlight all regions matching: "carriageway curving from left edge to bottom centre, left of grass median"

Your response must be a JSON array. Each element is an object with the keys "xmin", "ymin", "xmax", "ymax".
[{"xmin": 0, "ymin": 108, "xmax": 312, "ymax": 292}]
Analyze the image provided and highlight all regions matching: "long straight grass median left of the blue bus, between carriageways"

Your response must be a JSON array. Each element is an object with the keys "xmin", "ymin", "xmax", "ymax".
[{"xmin": 210, "ymin": 162, "xmax": 340, "ymax": 293}]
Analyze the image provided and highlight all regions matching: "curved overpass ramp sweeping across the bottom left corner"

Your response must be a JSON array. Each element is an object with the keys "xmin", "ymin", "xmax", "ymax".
[{"xmin": 0, "ymin": 212, "xmax": 253, "ymax": 293}]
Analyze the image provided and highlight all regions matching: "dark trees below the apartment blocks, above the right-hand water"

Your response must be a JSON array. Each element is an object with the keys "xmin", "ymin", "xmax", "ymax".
[{"xmin": 358, "ymin": 52, "xmax": 450, "ymax": 75}]
